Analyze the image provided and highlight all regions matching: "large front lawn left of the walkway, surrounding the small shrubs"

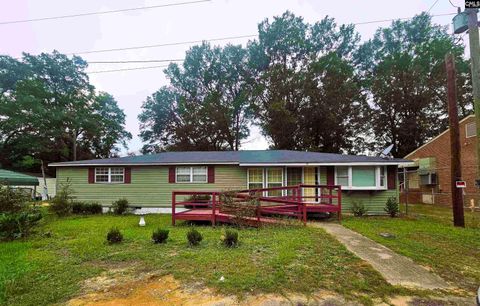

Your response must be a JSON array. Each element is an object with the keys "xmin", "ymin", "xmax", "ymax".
[{"xmin": 0, "ymin": 215, "xmax": 405, "ymax": 305}]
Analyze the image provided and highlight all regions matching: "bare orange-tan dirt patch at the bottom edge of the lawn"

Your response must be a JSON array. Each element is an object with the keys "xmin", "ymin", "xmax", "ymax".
[{"xmin": 67, "ymin": 268, "xmax": 357, "ymax": 306}]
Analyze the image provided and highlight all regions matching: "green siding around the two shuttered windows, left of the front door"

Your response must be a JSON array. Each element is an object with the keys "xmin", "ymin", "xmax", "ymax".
[{"xmin": 57, "ymin": 166, "xmax": 247, "ymax": 207}]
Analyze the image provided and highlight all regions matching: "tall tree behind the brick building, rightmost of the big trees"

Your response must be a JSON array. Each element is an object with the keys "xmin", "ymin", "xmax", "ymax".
[{"xmin": 356, "ymin": 14, "xmax": 471, "ymax": 156}]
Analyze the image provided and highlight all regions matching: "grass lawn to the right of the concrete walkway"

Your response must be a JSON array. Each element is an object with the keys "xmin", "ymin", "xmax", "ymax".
[{"xmin": 343, "ymin": 204, "xmax": 480, "ymax": 292}]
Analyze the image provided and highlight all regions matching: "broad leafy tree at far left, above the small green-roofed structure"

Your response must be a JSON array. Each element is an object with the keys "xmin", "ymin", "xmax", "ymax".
[{"xmin": 0, "ymin": 51, "xmax": 131, "ymax": 170}]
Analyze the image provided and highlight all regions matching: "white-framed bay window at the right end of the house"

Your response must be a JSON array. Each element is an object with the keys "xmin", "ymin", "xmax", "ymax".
[{"xmin": 335, "ymin": 166, "xmax": 387, "ymax": 190}]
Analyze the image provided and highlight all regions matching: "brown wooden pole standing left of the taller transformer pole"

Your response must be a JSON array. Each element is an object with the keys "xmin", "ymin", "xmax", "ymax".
[{"xmin": 445, "ymin": 54, "xmax": 465, "ymax": 227}]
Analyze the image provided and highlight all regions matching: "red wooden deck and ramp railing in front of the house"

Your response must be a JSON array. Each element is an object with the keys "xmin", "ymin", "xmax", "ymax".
[{"xmin": 172, "ymin": 184, "xmax": 342, "ymax": 225}]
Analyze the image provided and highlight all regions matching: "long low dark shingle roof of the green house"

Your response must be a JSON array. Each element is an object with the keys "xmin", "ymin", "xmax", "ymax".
[{"xmin": 49, "ymin": 150, "xmax": 409, "ymax": 167}]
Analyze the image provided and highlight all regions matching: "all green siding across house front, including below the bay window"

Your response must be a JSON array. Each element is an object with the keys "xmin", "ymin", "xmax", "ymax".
[{"xmin": 57, "ymin": 166, "xmax": 398, "ymax": 214}]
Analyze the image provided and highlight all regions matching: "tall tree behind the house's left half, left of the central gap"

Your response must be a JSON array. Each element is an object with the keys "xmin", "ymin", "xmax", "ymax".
[{"xmin": 139, "ymin": 43, "xmax": 251, "ymax": 152}]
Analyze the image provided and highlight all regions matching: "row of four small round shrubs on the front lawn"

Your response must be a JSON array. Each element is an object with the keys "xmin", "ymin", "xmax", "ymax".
[{"xmin": 107, "ymin": 227, "xmax": 238, "ymax": 248}]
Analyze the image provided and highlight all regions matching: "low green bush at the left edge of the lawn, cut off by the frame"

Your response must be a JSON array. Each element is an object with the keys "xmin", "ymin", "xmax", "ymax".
[{"xmin": 0, "ymin": 209, "xmax": 42, "ymax": 241}]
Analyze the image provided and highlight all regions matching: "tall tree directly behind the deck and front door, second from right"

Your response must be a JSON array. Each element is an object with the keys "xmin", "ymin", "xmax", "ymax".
[{"xmin": 249, "ymin": 12, "xmax": 365, "ymax": 152}]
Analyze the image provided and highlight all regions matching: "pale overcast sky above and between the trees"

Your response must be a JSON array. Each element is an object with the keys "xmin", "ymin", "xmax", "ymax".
[{"xmin": 0, "ymin": 0, "xmax": 464, "ymax": 154}]
